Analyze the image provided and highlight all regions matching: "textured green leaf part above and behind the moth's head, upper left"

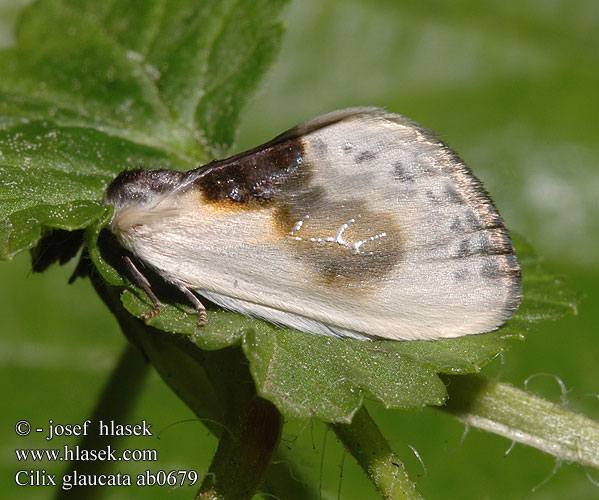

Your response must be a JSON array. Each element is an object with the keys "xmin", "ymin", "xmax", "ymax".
[{"xmin": 0, "ymin": 0, "xmax": 286, "ymax": 259}]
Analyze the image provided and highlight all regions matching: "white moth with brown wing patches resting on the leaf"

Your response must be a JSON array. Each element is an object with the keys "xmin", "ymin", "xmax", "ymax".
[{"xmin": 105, "ymin": 107, "xmax": 522, "ymax": 340}]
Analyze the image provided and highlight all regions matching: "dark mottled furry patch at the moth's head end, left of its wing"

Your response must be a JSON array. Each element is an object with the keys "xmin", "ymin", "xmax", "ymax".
[{"xmin": 104, "ymin": 169, "xmax": 183, "ymax": 212}]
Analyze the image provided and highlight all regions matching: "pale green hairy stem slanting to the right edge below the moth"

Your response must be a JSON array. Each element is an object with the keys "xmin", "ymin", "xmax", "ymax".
[{"xmin": 439, "ymin": 375, "xmax": 599, "ymax": 469}]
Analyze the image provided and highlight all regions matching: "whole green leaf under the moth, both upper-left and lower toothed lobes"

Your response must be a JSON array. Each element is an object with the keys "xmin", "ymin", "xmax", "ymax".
[{"xmin": 0, "ymin": 0, "xmax": 575, "ymax": 422}]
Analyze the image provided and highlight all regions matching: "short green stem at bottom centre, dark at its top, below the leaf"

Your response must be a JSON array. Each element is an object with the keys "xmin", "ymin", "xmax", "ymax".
[{"xmin": 329, "ymin": 407, "xmax": 422, "ymax": 500}]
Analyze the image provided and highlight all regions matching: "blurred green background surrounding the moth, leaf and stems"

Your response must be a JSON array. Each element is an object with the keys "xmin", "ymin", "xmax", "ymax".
[{"xmin": 0, "ymin": 0, "xmax": 599, "ymax": 500}]
